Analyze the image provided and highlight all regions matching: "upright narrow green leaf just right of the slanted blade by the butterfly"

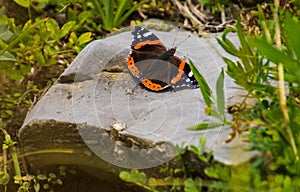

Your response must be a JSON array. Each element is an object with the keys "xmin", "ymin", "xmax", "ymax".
[{"xmin": 216, "ymin": 69, "xmax": 225, "ymax": 120}]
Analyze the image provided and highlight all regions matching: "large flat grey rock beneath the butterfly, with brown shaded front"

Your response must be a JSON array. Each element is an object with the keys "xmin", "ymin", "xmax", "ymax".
[{"xmin": 20, "ymin": 21, "xmax": 255, "ymax": 190}]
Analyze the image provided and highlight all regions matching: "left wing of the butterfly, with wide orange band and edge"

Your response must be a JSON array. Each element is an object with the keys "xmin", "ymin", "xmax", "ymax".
[{"xmin": 127, "ymin": 26, "xmax": 170, "ymax": 91}]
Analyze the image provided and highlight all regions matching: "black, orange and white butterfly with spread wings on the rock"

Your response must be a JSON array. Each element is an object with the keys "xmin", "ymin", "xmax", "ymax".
[{"xmin": 127, "ymin": 26, "xmax": 199, "ymax": 91}]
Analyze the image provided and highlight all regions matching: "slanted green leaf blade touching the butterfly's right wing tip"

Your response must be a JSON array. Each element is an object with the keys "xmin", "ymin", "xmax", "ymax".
[{"xmin": 189, "ymin": 60, "xmax": 212, "ymax": 107}]
